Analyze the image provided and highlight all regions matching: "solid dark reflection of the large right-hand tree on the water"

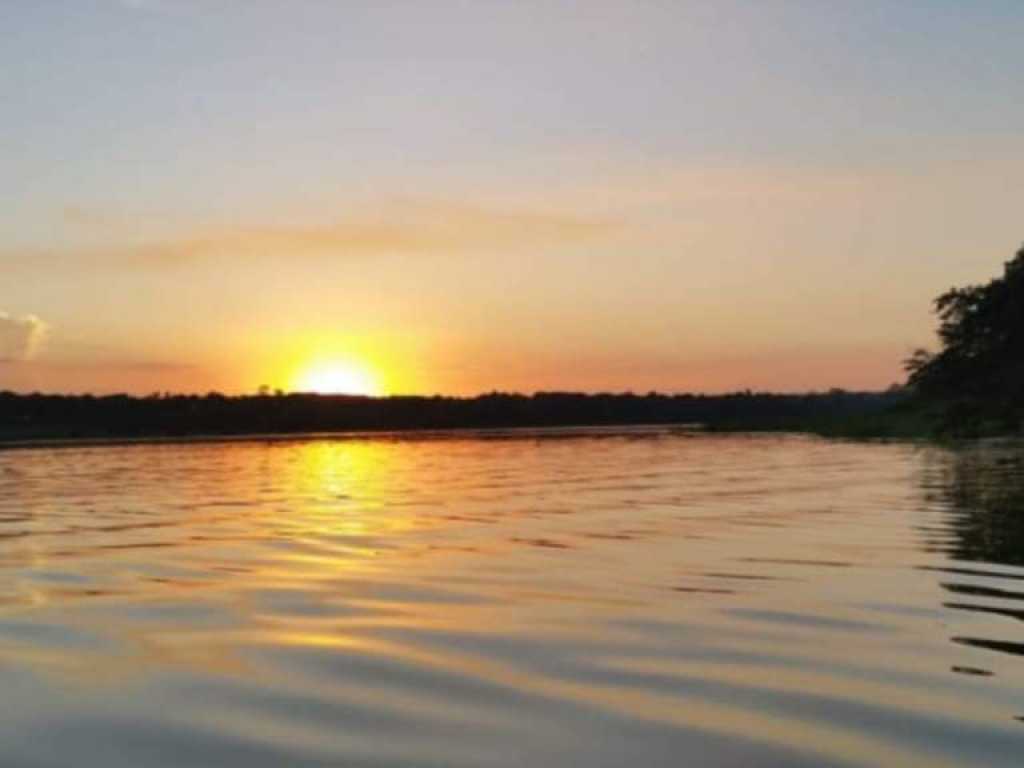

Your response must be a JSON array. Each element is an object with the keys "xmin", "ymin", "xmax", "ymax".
[{"xmin": 928, "ymin": 441, "xmax": 1024, "ymax": 565}]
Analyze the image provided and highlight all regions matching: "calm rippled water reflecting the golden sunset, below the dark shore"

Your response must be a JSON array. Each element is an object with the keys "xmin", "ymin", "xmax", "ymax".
[{"xmin": 0, "ymin": 430, "xmax": 1024, "ymax": 768}]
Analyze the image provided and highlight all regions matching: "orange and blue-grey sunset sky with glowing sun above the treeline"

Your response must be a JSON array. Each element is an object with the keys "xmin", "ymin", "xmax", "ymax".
[{"xmin": 0, "ymin": 0, "xmax": 1024, "ymax": 394}]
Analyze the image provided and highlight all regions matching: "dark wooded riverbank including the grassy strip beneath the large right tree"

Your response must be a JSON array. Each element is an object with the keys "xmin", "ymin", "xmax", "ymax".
[{"xmin": 0, "ymin": 391, "xmax": 1021, "ymax": 449}]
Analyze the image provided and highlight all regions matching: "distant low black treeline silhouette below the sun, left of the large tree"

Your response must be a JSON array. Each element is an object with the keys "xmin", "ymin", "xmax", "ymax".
[{"xmin": 0, "ymin": 390, "xmax": 903, "ymax": 441}]
